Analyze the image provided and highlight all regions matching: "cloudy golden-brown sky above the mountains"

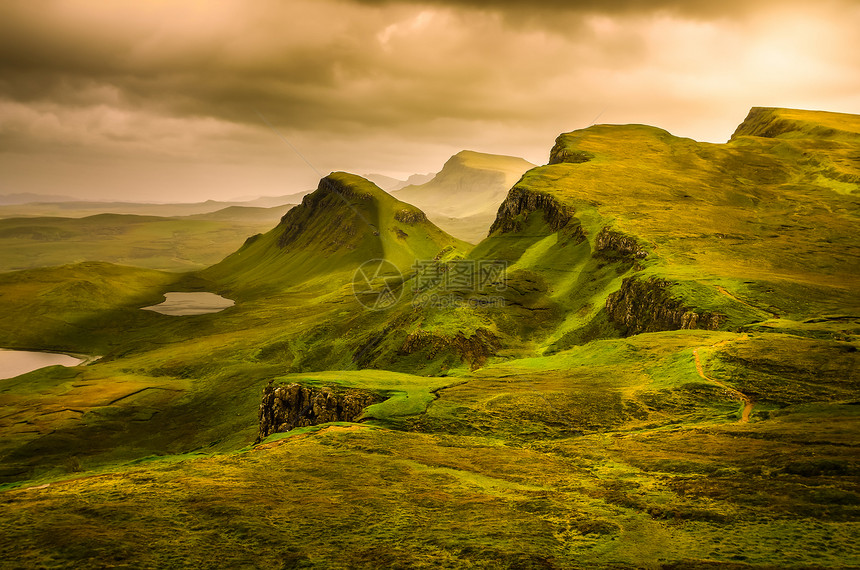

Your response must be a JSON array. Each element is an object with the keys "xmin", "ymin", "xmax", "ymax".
[{"xmin": 0, "ymin": 0, "xmax": 860, "ymax": 202}]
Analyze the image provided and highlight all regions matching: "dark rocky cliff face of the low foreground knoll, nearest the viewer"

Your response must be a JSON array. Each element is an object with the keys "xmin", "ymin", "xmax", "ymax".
[{"xmin": 257, "ymin": 383, "xmax": 385, "ymax": 442}]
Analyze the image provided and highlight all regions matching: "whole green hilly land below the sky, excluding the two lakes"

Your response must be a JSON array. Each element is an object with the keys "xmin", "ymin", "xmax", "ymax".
[{"xmin": 0, "ymin": 108, "xmax": 860, "ymax": 570}]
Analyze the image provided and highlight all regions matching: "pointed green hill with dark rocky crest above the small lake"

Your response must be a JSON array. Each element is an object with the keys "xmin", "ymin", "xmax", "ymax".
[{"xmin": 202, "ymin": 172, "xmax": 469, "ymax": 294}]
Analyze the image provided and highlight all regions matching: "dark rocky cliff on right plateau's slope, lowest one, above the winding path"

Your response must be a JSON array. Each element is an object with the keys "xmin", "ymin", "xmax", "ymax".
[{"xmin": 606, "ymin": 277, "xmax": 726, "ymax": 336}]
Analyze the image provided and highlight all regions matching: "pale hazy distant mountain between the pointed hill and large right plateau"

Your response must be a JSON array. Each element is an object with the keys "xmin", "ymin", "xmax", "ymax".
[{"xmin": 397, "ymin": 150, "xmax": 534, "ymax": 243}]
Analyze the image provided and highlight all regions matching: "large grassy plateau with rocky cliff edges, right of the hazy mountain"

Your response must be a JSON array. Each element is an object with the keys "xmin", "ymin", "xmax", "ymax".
[{"xmin": 472, "ymin": 106, "xmax": 860, "ymax": 350}]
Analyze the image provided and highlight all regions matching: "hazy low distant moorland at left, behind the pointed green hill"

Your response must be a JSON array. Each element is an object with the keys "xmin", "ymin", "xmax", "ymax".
[{"xmin": 0, "ymin": 205, "xmax": 291, "ymax": 272}]
